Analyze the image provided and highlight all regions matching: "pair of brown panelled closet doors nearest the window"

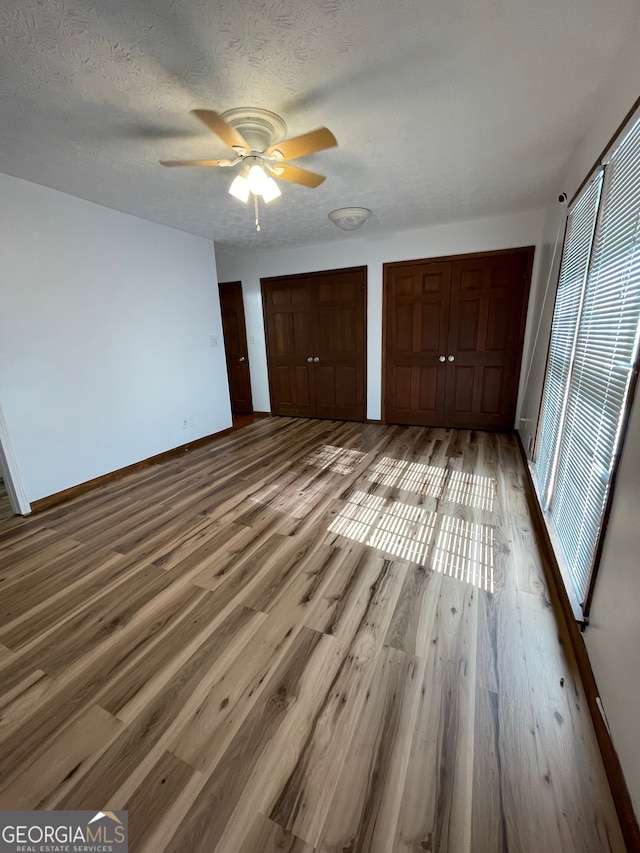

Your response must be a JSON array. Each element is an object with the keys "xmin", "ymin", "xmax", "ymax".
[{"xmin": 385, "ymin": 249, "xmax": 533, "ymax": 430}]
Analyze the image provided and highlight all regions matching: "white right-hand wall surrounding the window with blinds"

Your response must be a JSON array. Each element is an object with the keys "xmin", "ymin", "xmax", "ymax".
[{"xmin": 523, "ymin": 21, "xmax": 640, "ymax": 815}]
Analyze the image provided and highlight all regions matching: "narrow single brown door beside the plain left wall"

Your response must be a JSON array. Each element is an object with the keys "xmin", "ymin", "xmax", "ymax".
[{"xmin": 218, "ymin": 281, "xmax": 253, "ymax": 414}]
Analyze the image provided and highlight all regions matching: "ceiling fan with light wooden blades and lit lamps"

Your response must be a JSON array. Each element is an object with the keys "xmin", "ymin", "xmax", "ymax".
[{"xmin": 160, "ymin": 107, "xmax": 338, "ymax": 215}]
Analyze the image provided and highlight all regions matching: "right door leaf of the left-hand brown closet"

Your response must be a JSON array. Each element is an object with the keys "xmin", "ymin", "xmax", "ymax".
[{"xmin": 313, "ymin": 269, "xmax": 366, "ymax": 421}]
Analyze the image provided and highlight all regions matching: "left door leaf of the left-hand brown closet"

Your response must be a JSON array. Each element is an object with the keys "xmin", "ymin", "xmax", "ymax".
[{"xmin": 262, "ymin": 278, "xmax": 316, "ymax": 417}]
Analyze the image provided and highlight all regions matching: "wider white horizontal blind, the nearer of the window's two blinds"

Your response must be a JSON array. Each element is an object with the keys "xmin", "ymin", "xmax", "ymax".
[{"xmin": 551, "ymin": 115, "xmax": 640, "ymax": 603}]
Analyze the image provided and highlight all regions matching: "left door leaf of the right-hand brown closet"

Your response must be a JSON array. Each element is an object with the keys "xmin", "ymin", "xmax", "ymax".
[{"xmin": 385, "ymin": 261, "xmax": 451, "ymax": 426}]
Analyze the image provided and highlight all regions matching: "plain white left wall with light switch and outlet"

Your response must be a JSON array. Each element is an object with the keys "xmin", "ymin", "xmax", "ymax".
[{"xmin": 0, "ymin": 175, "xmax": 231, "ymax": 501}]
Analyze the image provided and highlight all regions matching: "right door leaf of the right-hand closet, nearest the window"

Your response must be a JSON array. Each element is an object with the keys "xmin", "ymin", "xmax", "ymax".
[{"xmin": 444, "ymin": 252, "xmax": 529, "ymax": 430}]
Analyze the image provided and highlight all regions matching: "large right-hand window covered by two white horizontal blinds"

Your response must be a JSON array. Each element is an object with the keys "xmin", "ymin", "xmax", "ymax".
[{"xmin": 535, "ymin": 108, "xmax": 640, "ymax": 613}]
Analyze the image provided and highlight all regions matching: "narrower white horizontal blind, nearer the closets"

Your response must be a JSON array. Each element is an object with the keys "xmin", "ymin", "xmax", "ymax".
[{"xmin": 536, "ymin": 176, "xmax": 603, "ymax": 507}]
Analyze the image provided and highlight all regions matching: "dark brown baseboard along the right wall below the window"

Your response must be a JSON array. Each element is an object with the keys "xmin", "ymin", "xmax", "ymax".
[{"xmin": 516, "ymin": 432, "xmax": 640, "ymax": 850}]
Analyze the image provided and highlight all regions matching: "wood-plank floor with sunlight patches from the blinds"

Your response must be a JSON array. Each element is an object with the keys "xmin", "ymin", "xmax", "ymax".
[{"xmin": 0, "ymin": 418, "xmax": 624, "ymax": 853}]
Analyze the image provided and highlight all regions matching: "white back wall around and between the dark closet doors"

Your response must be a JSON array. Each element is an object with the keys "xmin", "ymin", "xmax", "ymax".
[{"xmin": 216, "ymin": 206, "xmax": 543, "ymax": 420}]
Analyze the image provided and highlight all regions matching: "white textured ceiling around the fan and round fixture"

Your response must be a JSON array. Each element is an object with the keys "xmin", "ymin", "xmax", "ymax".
[{"xmin": 0, "ymin": 0, "xmax": 639, "ymax": 252}]
